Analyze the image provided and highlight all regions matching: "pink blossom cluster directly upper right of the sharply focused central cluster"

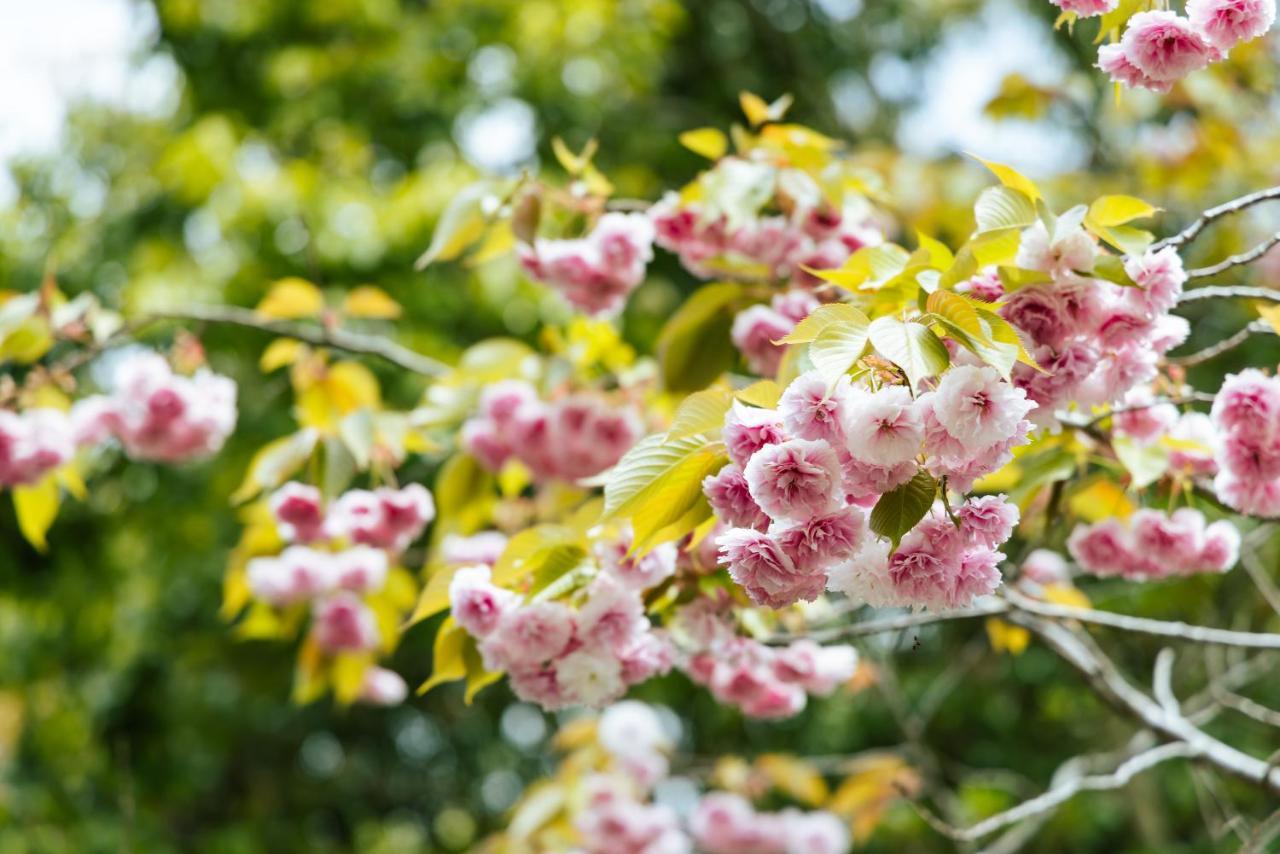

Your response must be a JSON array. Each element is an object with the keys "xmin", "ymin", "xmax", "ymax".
[{"xmin": 1000, "ymin": 229, "xmax": 1189, "ymax": 425}]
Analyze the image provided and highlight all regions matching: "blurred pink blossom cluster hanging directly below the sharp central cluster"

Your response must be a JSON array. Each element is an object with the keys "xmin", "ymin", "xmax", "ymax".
[{"xmin": 672, "ymin": 599, "xmax": 858, "ymax": 718}]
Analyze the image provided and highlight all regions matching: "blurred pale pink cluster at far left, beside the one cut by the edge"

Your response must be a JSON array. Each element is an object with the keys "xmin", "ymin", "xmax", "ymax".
[{"xmin": 72, "ymin": 351, "xmax": 236, "ymax": 462}]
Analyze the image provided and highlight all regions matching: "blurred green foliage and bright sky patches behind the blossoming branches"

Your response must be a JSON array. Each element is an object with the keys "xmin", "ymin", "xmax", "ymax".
[{"xmin": 0, "ymin": 0, "xmax": 1280, "ymax": 851}]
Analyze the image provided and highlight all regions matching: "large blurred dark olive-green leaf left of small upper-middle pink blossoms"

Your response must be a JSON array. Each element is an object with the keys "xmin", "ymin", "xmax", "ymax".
[{"xmin": 655, "ymin": 282, "xmax": 742, "ymax": 392}]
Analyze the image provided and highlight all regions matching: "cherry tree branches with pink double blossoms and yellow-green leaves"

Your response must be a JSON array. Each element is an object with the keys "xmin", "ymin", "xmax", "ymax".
[{"xmin": 0, "ymin": 28, "xmax": 1280, "ymax": 853}]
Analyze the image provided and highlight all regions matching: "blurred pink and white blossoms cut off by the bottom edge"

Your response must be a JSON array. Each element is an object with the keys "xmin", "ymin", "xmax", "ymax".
[{"xmin": 571, "ymin": 700, "xmax": 851, "ymax": 854}]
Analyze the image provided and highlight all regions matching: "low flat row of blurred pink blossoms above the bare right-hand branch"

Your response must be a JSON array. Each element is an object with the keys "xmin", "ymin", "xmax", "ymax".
[{"xmin": 1066, "ymin": 507, "xmax": 1240, "ymax": 581}]
